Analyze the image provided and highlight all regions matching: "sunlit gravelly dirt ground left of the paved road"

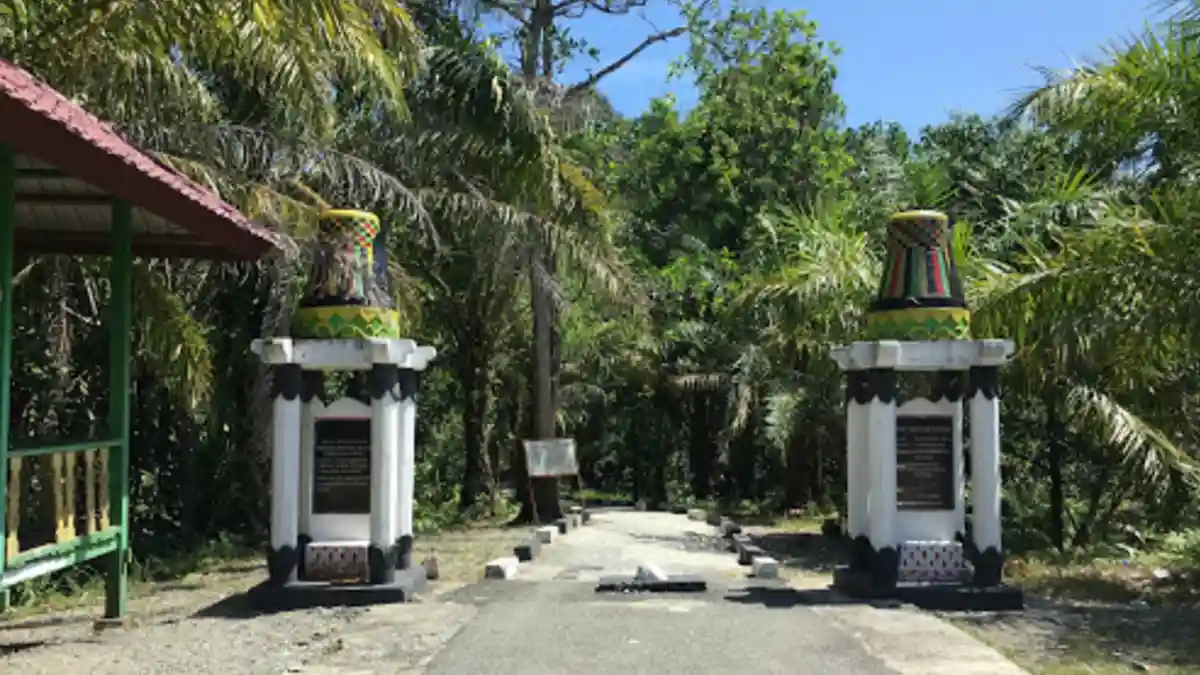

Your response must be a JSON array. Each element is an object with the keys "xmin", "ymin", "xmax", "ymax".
[{"xmin": 0, "ymin": 528, "xmax": 526, "ymax": 675}]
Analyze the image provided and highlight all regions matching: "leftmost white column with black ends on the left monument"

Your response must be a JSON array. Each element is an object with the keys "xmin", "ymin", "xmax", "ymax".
[{"xmin": 269, "ymin": 364, "xmax": 300, "ymax": 581}]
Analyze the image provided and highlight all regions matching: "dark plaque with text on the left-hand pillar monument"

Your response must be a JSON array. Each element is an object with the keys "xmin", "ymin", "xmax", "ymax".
[{"xmin": 312, "ymin": 419, "xmax": 371, "ymax": 513}]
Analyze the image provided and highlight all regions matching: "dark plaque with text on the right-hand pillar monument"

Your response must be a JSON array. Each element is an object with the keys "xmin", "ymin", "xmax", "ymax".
[{"xmin": 896, "ymin": 416, "xmax": 954, "ymax": 510}]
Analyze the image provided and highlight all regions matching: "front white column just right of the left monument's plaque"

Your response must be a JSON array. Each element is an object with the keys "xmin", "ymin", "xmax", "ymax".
[{"xmin": 371, "ymin": 364, "xmax": 401, "ymax": 584}]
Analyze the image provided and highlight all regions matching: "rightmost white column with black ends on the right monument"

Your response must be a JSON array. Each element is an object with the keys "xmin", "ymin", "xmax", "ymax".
[{"xmin": 971, "ymin": 368, "xmax": 1003, "ymax": 552}]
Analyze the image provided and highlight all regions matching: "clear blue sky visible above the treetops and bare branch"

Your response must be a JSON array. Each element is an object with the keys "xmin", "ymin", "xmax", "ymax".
[{"xmin": 496, "ymin": 0, "xmax": 1160, "ymax": 131}]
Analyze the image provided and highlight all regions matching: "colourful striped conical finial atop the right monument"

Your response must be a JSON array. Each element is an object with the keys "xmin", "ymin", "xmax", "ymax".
[{"xmin": 866, "ymin": 210, "xmax": 971, "ymax": 340}]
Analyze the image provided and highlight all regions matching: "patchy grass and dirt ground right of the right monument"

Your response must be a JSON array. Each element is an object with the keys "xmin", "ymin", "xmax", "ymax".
[{"xmin": 955, "ymin": 532, "xmax": 1200, "ymax": 675}]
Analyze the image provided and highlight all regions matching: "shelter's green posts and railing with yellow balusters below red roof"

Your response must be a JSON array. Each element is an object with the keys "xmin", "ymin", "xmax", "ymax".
[{"xmin": 0, "ymin": 144, "xmax": 133, "ymax": 619}]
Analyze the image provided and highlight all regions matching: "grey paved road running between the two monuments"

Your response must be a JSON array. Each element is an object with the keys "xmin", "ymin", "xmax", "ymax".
[{"xmin": 427, "ymin": 512, "xmax": 1022, "ymax": 675}]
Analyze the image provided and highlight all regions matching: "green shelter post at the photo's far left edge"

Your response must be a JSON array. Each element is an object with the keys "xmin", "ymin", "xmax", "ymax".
[{"xmin": 0, "ymin": 143, "xmax": 17, "ymax": 611}]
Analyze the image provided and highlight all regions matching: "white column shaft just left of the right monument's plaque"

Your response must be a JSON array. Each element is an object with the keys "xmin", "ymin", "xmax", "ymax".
[{"xmin": 864, "ymin": 387, "xmax": 899, "ymax": 551}]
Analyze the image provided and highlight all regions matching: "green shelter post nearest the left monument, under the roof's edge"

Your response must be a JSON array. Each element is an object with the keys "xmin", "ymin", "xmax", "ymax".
[{"xmin": 104, "ymin": 199, "xmax": 133, "ymax": 620}]
